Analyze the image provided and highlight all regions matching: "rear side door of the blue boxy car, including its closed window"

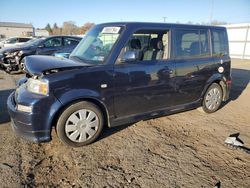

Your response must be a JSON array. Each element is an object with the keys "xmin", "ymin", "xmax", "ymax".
[{"xmin": 174, "ymin": 29, "xmax": 214, "ymax": 105}]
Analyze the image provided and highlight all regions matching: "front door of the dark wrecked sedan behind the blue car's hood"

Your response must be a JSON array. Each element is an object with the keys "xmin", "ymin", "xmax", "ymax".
[{"xmin": 36, "ymin": 37, "xmax": 63, "ymax": 55}]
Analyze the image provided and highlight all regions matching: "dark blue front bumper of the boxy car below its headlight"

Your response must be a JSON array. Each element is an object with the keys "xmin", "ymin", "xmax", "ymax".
[{"xmin": 7, "ymin": 86, "xmax": 61, "ymax": 143}]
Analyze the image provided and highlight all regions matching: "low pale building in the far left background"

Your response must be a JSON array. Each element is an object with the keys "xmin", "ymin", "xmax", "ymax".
[{"xmin": 0, "ymin": 22, "xmax": 34, "ymax": 38}]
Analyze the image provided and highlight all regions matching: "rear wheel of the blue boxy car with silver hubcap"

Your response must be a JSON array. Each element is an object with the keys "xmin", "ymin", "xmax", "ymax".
[{"xmin": 202, "ymin": 83, "xmax": 223, "ymax": 113}]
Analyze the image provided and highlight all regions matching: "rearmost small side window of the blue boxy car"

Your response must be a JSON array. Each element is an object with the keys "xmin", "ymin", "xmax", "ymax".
[{"xmin": 212, "ymin": 30, "xmax": 228, "ymax": 55}]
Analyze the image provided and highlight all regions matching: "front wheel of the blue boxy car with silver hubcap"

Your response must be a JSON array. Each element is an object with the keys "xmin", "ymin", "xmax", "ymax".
[{"xmin": 56, "ymin": 101, "xmax": 104, "ymax": 147}]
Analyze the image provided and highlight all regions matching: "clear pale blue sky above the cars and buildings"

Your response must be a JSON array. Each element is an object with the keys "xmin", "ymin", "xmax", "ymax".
[{"xmin": 0, "ymin": 0, "xmax": 250, "ymax": 28}]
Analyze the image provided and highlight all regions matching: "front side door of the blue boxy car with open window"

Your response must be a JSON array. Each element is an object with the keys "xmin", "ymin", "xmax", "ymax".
[{"xmin": 114, "ymin": 31, "xmax": 175, "ymax": 118}]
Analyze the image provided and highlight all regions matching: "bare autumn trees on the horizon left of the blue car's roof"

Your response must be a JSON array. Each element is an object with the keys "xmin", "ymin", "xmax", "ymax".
[{"xmin": 44, "ymin": 21, "xmax": 95, "ymax": 35}]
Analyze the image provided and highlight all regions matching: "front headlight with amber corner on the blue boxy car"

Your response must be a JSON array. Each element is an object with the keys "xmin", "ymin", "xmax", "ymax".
[{"xmin": 27, "ymin": 78, "xmax": 49, "ymax": 95}]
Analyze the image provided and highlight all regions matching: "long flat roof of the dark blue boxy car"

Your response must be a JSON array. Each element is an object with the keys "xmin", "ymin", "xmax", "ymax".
[{"xmin": 98, "ymin": 22, "xmax": 225, "ymax": 29}]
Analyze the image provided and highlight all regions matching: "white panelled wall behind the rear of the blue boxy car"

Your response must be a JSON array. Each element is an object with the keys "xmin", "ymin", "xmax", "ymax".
[{"xmin": 224, "ymin": 23, "xmax": 250, "ymax": 59}]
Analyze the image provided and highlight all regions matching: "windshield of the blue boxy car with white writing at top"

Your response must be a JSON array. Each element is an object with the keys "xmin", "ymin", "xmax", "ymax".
[{"xmin": 70, "ymin": 26, "xmax": 122, "ymax": 65}]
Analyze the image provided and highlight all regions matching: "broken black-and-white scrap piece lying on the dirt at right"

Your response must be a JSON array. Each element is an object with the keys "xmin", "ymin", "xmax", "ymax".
[{"xmin": 225, "ymin": 133, "xmax": 250, "ymax": 154}]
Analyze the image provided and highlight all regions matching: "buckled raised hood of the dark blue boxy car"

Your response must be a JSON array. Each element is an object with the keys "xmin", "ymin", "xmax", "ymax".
[{"xmin": 24, "ymin": 55, "xmax": 89, "ymax": 76}]
